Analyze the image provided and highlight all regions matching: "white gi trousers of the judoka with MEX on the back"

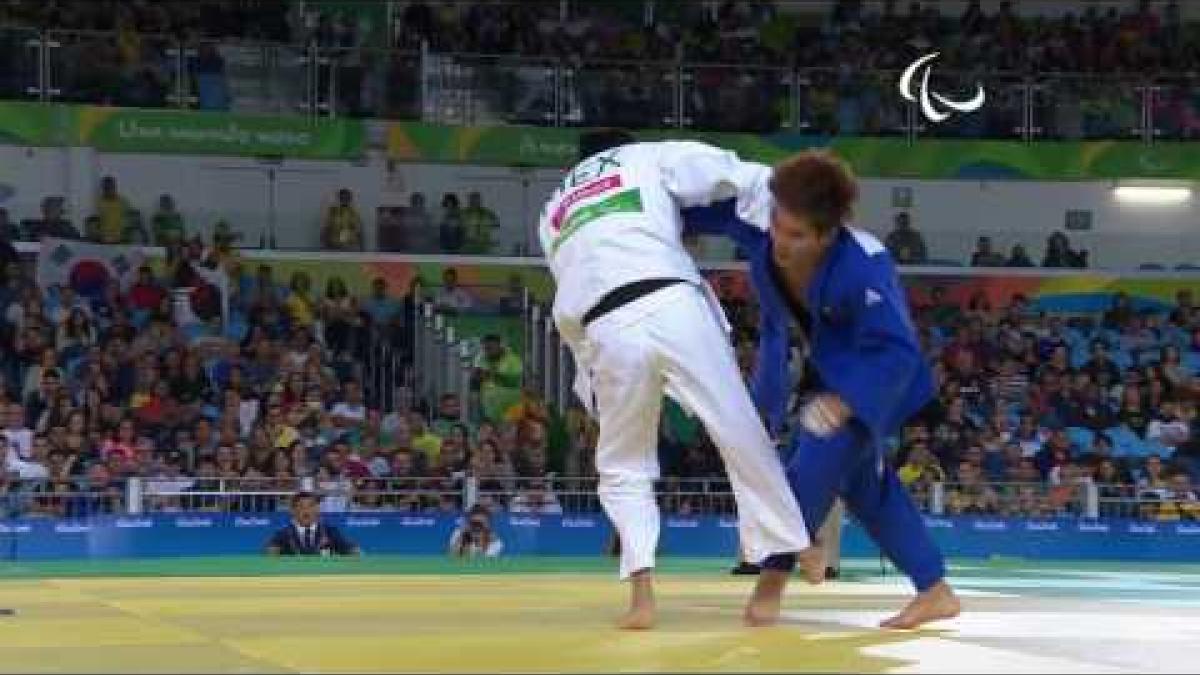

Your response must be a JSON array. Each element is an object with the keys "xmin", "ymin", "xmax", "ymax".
[{"xmin": 576, "ymin": 282, "xmax": 809, "ymax": 580}]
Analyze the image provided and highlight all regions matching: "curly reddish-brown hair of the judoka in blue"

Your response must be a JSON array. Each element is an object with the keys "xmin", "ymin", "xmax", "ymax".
[{"xmin": 770, "ymin": 150, "xmax": 858, "ymax": 234}]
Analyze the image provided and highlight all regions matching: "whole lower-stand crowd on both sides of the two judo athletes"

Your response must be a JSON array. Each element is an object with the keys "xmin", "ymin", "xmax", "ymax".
[{"xmin": 0, "ymin": 205, "xmax": 1200, "ymax": 520}]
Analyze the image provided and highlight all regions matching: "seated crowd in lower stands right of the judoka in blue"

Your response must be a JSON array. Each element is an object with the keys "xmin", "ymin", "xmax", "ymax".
[{"xmin": 722, "ymin": 276, "xmax": 1200, "ymax": 520}]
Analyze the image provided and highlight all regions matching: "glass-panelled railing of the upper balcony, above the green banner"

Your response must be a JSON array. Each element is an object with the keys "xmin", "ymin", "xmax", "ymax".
[{"xmin": 0, "ymin": 26, "xmax": 1200, "ymax": 142}]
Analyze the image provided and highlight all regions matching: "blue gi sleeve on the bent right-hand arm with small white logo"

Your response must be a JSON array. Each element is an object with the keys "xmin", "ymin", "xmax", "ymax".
[{"xmin": 833, "ymin": 261, "xmax": 928, "ymax": 437}]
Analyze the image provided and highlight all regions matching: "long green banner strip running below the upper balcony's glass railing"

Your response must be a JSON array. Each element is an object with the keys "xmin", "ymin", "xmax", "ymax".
[{"xmin": 0, "ymin": 102, "xmax": 1200, "ymax": 180}]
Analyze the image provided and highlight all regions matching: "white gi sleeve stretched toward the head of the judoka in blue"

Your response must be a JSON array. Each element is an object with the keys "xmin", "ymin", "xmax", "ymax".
[{"xmin": 659, "ymin": 141, "xmax": 772, "ymax": 229}]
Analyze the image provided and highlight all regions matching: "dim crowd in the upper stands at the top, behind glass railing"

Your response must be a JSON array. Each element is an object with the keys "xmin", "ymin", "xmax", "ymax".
[{"xmin": 0, "ymin": 0, "xmax": 1200, "ymax": 138}]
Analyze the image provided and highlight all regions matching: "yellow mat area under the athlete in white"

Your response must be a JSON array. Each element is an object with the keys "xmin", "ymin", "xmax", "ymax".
[{"xmin": 0, "ymin": 574, "xmax": 926, "ymax": 673}]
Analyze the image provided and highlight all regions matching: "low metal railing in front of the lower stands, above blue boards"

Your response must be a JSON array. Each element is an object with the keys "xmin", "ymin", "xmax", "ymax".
[{"xmin": 0, "ymin": 473, "xmax": 1200, "ymax": 521}]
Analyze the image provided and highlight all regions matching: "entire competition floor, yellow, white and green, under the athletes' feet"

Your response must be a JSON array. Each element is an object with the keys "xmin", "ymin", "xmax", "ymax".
[{"xmin": 0, "ymin": 557, "xmax": 1200, "ymax": 673}]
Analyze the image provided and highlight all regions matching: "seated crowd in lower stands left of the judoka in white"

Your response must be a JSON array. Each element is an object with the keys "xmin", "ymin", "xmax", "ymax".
[{"xmin": 0, "ymin": 205, "xmax": 590, "ymax": 516}]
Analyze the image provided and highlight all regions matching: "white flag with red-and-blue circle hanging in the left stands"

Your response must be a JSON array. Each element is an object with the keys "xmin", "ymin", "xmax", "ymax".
[{"xmin": 37, "ymin": 239, "xmax": 145, "ymax": 295}]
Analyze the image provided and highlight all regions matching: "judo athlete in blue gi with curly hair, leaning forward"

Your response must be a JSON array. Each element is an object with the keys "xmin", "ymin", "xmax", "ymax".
[{"xmin": 685, "ymin": 151, "xmax": 960, "ymax": 628}]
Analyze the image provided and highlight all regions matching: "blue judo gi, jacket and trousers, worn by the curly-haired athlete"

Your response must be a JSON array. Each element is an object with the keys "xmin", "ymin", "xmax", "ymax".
[{"xmin": 684, "ymin": 202, "xmax": 946, "ymax": 591}]
